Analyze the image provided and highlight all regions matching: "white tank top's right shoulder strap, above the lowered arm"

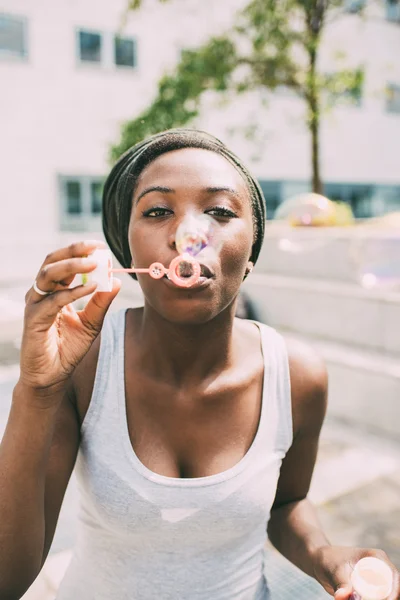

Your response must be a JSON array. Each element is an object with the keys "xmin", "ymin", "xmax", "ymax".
[{"xmin": 256, "ymin": 322, "xmax": 293, "ymax": 455}]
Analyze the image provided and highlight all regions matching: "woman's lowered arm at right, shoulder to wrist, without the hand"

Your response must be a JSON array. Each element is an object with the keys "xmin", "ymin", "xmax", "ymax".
[{"xmin": 268, "ymin": 343, "xmax": 329, "ymax": 576}]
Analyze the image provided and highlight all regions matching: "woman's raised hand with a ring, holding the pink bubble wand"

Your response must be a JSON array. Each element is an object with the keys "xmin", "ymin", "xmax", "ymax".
[{"xmin": 20, "ymin": 241, "xmax": 121, "ymax": 395}]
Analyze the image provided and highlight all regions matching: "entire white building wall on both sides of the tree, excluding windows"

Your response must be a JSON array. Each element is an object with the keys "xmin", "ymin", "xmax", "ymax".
[{"xmin": 0, "ymin": 0, "xmax": 400, "ymax": 282}]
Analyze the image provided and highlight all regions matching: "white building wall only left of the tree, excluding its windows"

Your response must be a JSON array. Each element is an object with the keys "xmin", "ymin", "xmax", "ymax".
[{"xmin": 0, "ymin": 0, "xmax": 244, "ymax": 280}]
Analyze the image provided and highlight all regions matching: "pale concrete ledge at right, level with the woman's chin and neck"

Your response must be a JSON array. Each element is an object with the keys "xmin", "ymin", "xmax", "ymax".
[{"xmin": 245, "ymin": 273, "xmax": 400, "ymax": 354}]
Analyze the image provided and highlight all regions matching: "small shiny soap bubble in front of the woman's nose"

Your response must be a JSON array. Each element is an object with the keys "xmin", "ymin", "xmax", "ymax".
[{"xmin": 175, "ymin": 214, "xmax": 221, "ymax": 257}]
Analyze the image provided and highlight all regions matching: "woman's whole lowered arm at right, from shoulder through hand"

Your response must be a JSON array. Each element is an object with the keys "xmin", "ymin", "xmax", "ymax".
[{"xmin": 268, "ymin": 344, "xmax": 400, "ymax": 600}]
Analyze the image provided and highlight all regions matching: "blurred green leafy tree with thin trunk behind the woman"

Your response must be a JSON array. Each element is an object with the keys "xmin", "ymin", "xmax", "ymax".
[{"xmin": 111, "ymin": 0, "xmax": 364, "ymax": 193}]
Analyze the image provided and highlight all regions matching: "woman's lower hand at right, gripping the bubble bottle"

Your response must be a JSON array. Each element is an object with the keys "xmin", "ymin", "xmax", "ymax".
[{"xmin": 315, "ymin": 546, "xmax": 400, "ymax": 600}]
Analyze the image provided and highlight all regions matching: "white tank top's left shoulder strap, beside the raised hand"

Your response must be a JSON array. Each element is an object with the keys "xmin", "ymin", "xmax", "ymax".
[{"xmin": 81, "ymin": 309, "xmax": 126, "ymax": 436}]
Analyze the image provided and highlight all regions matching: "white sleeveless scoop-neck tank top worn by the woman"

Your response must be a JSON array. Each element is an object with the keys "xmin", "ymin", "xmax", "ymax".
[{"xmin": 57, "ymin": 310, "xmax": 292, "ymax": 600}]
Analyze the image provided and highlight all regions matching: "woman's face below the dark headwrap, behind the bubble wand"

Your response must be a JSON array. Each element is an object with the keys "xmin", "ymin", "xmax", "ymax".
[{"xmin": 128, "ymin": 148, "xmax": 253, "ymax": 324}]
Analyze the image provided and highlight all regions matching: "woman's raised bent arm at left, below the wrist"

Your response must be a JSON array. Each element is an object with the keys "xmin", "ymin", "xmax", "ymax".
[{"xmin": 0, "ymin": 383, "xmax": 79, "ymax": 600}]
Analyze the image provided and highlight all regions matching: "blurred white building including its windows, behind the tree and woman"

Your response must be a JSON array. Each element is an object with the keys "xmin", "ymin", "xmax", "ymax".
[{"xmin": 0, "ymin": 0, "xmax": 400, "ymax": 282}]
